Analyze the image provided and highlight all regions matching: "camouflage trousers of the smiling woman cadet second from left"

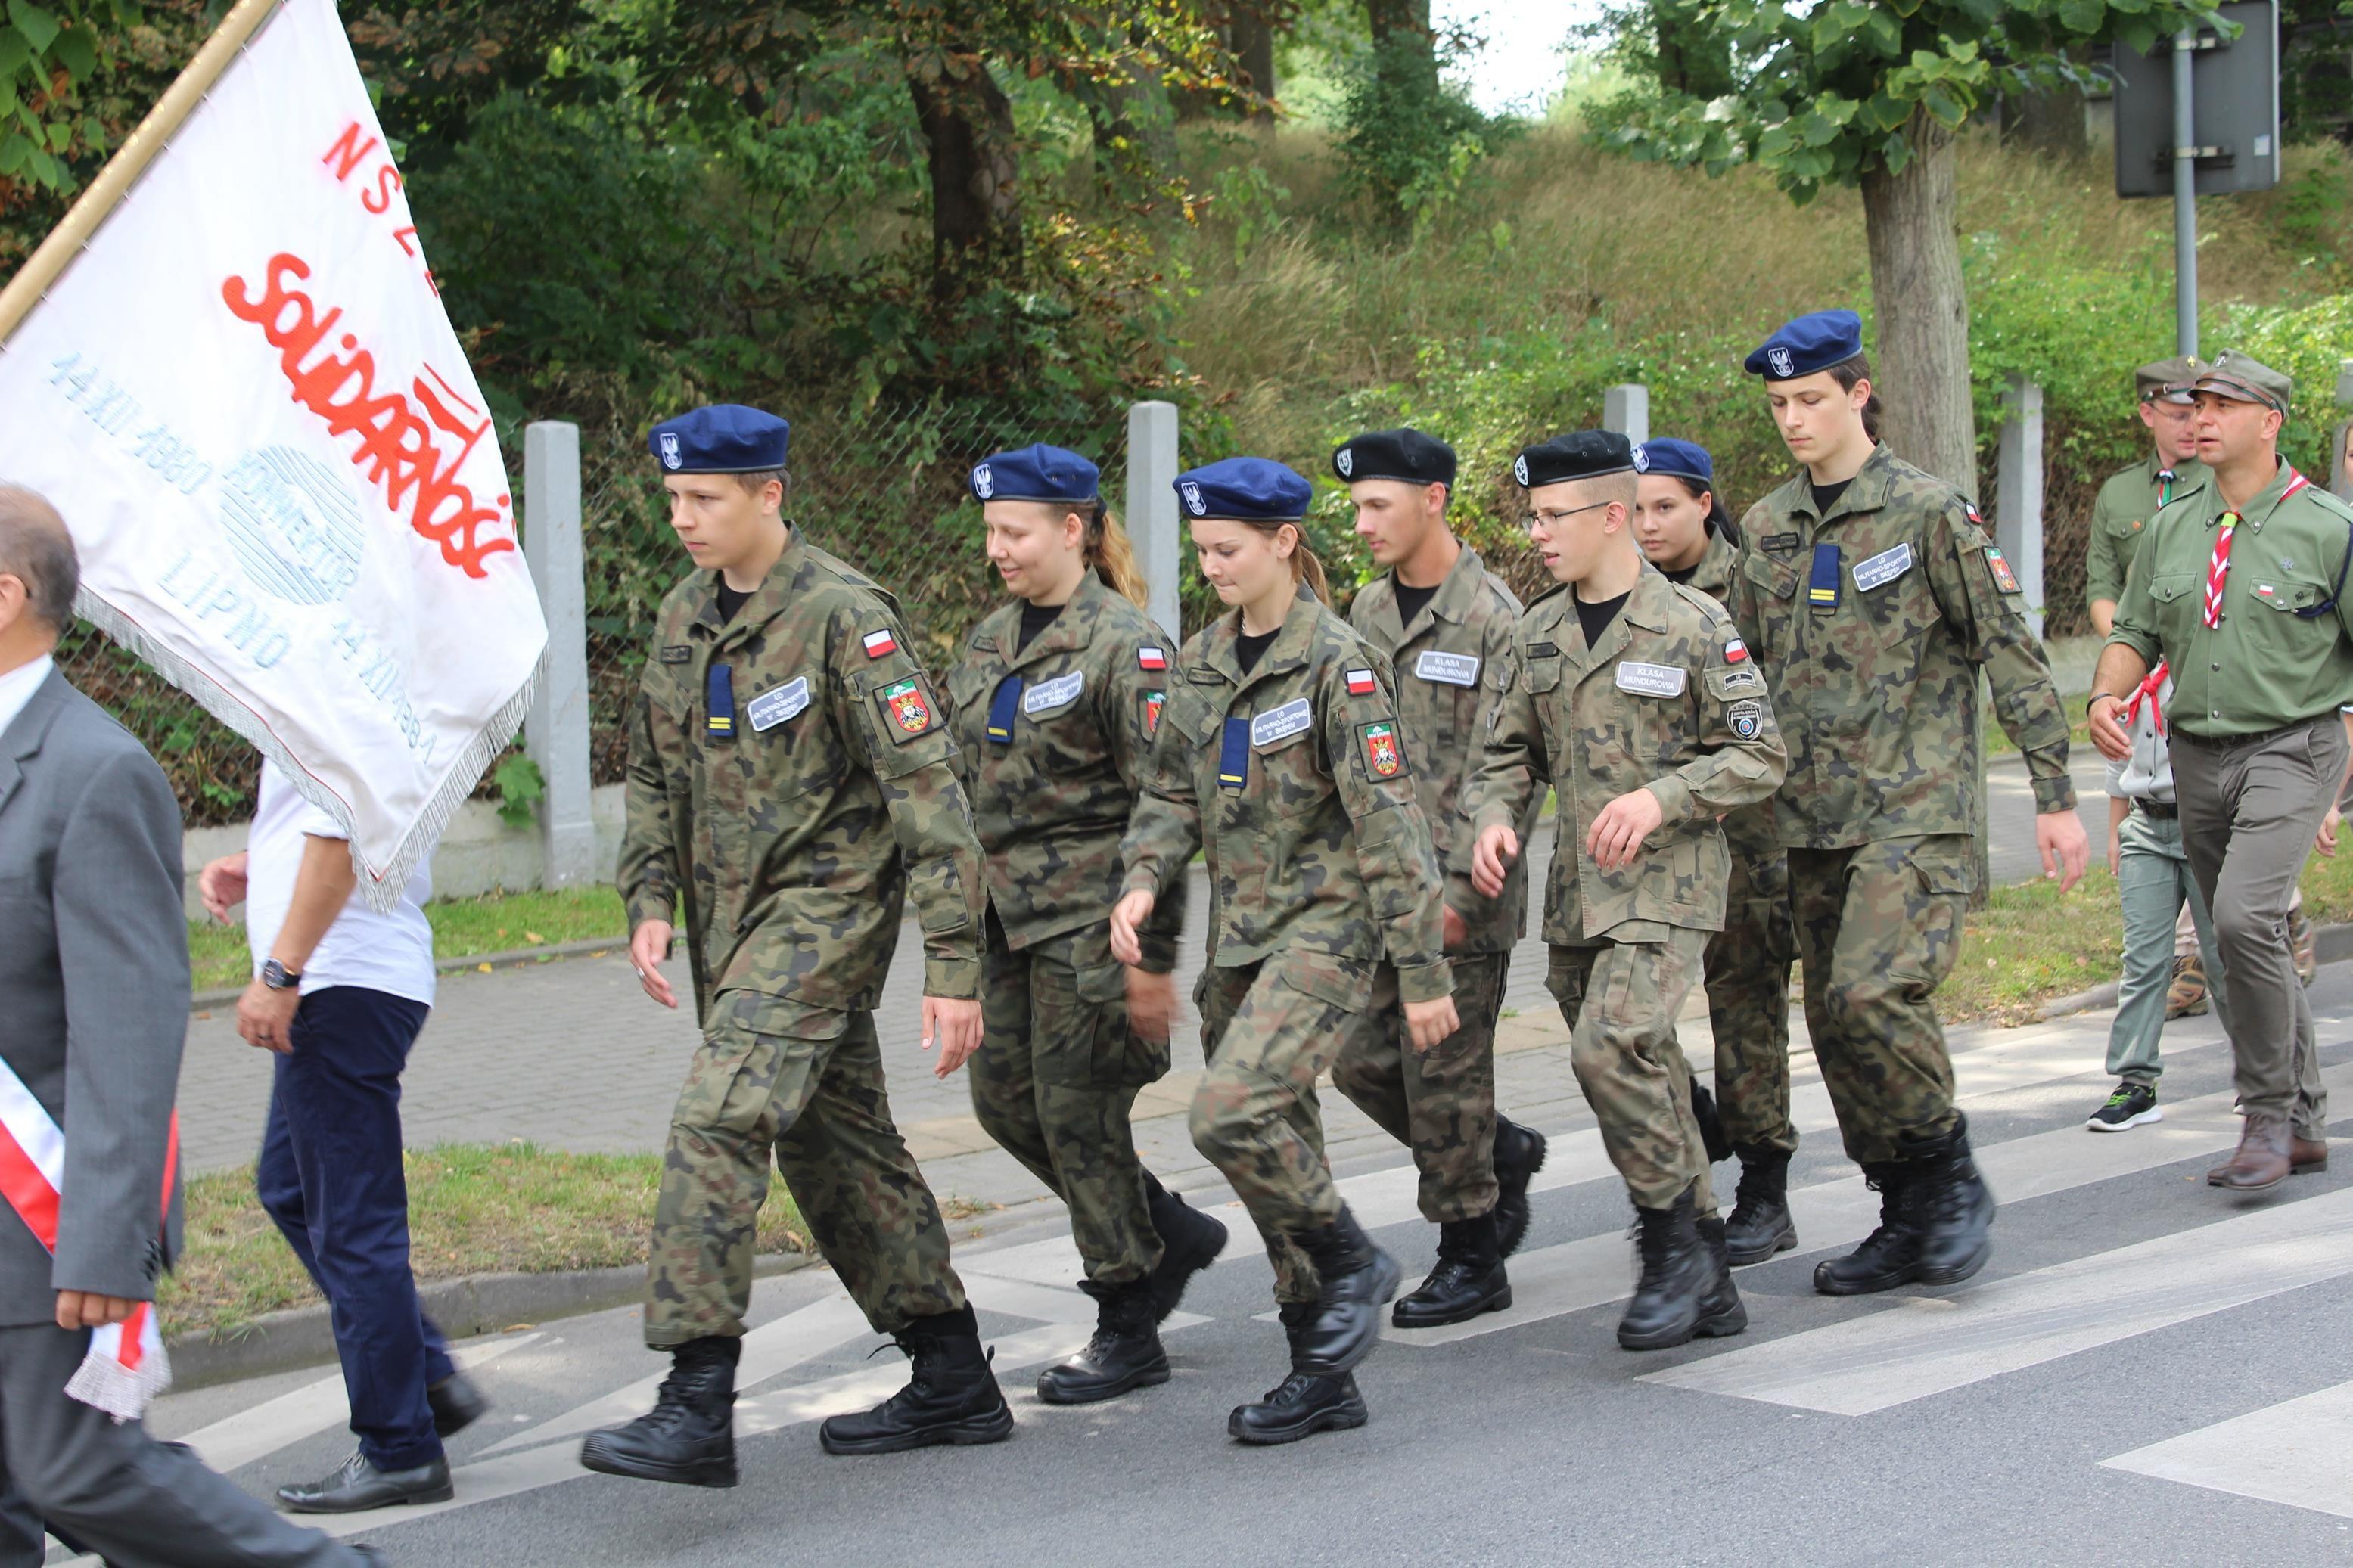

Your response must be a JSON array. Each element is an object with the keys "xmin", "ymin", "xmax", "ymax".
[{"xmin": 965, "ymin": 912, "xmax": 1170, "ymax": 1284}]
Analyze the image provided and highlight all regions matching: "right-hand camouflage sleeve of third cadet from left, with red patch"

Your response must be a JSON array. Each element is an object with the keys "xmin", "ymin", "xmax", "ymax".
[{"xmin": 1315, "ymin": 649, "xmax": 1454, "ymax": 1001}]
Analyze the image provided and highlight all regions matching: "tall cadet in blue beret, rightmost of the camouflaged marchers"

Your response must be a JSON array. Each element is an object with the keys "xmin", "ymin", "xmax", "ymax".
[{"xmin": 1730, "ymin": 310, "xmax": 2090, "ymax": 1295}]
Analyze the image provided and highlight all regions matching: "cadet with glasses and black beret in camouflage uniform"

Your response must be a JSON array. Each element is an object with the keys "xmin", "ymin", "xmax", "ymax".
[{"xmin": 1452, "ymin": 430, "xmax": 1783, "ymax": 1349}]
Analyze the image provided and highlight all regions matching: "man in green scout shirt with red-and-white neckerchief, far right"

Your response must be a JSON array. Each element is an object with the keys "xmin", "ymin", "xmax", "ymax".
[{"xmin": 2092, "ymin": 352, "xmax": 2353, "ymax": 1192}]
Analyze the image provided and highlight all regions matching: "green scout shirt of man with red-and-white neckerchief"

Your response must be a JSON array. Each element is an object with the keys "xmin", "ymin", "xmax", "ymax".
[{"xmin": 2109, "ymin": 463, "xmax": 2353, "ymax": 738}]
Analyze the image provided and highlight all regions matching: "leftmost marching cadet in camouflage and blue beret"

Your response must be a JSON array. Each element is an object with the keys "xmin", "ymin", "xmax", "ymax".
[{"xmin": 581, "ymin": 405, "xmax": 1014, "ymax": 1486}]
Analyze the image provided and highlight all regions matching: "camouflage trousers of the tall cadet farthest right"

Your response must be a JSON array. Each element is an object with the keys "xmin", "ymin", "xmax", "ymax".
[{"xmin": 1789, "ymin": 834, "xmax": 1976, "ymax": 1163}]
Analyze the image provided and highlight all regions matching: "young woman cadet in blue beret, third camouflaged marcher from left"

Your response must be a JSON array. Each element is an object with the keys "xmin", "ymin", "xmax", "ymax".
[{"xmin": 1111, "ymin": 458, "xmax": 1459, "ymax": 1443}]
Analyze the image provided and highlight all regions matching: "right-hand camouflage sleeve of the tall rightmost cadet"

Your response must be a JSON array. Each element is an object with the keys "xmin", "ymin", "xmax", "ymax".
[{"xmin": 1922, "ymin": 496, "xmax": 2075, "ymax": 815}]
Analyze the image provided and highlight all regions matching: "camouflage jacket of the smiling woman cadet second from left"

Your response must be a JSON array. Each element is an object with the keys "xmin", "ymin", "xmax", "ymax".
[{"xmin": 948, "ymin": 571, "xmax": 1186, "ymax": 973}]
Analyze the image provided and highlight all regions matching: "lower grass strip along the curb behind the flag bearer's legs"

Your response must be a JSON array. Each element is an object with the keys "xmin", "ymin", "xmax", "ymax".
[{"xmin": 157, "ymin": 1138, "xmax": 810, "ymax": 1335}]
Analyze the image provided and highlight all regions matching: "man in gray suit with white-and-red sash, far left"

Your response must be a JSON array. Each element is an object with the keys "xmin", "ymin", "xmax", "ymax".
[{"xmin": 0, "ymin": 484, "xmax": 381, "ymax": 1568}]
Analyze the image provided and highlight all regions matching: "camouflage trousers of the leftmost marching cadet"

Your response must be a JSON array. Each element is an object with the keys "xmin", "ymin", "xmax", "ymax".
[{"xmin": 645, "ymin": 992, "xmax": 965, "ymax": 1349}]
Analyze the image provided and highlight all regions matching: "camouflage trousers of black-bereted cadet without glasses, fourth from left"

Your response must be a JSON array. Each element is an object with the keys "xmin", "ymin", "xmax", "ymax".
[{"xmin": 1332, "ymin": 952, "xmax": 1511, "ymax": 1225}]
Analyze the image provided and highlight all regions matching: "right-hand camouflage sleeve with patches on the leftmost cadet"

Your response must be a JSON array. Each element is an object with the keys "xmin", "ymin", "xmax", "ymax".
[{"xmin": 828, "ymin": 616, "xmax": 988, "ymax": 1001}]
